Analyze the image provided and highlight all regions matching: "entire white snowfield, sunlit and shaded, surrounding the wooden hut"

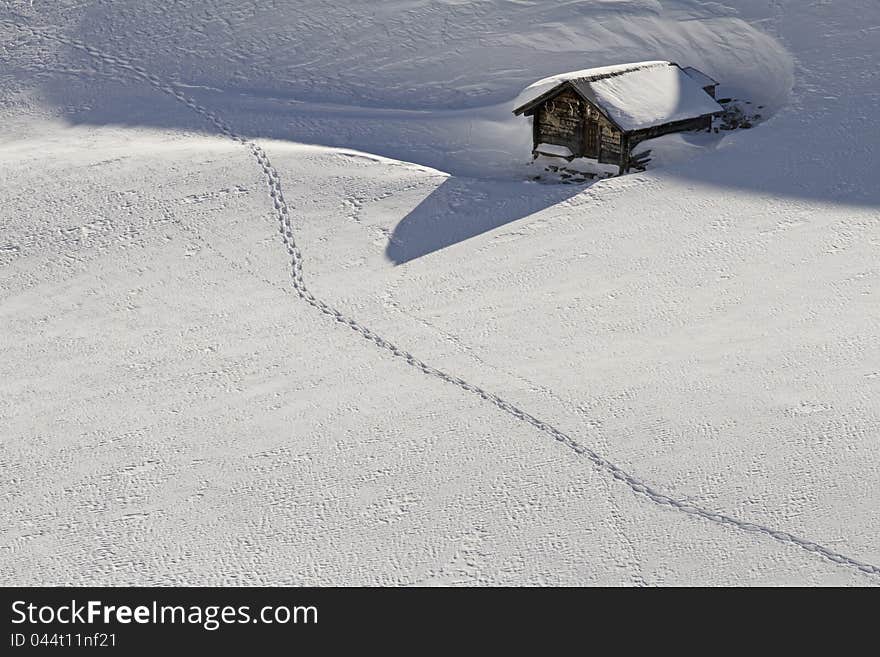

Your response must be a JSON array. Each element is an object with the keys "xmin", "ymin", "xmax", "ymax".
[{"xmin": 0, "ymin": 0, "xmax": 880, "ymax": 586}]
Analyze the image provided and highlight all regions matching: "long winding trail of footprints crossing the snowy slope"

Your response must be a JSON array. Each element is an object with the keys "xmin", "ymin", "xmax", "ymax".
[{"xmin": 8, "ymin": 18, "xmax": 880, "ymax": 576}]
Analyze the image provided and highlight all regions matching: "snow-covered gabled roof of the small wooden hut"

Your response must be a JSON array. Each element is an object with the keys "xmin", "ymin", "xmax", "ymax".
[{"xmin": 514, "ymin": 61, "xmax": 723, "ymax": 131}]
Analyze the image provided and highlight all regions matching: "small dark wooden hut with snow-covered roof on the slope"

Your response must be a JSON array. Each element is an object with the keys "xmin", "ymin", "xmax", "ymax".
[{"xmin": 513, "ymin": 61, "xmax": 723, "ymax": 173}]
